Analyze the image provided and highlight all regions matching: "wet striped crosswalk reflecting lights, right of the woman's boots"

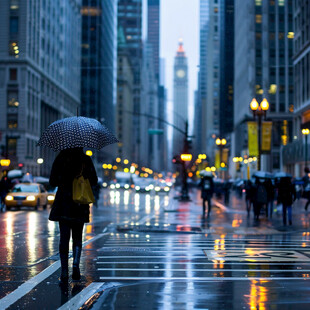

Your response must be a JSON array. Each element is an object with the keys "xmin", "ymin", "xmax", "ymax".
[{"xmin": 96, "ymin": 233, "xmax": 310, "ymax": 281}]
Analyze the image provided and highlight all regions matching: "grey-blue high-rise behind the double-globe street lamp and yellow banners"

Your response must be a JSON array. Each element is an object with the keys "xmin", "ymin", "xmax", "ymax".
[{"xmin": 231, "ymin": 0, "xmax": 294, "ymax": 176}]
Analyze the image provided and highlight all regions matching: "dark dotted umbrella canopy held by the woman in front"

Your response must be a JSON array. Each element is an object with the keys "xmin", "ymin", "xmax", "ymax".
[{"xmin": 38, "ymin": 116, "xmax": 118, "ymax": 151}]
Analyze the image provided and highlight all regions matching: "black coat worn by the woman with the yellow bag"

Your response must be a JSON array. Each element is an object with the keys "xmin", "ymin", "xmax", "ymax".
[{"xmin": 49, "ymin": 149, "xmax": 98, "ymax": 223}]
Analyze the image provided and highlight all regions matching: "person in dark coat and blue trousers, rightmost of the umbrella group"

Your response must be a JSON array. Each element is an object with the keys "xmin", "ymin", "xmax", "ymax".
[{"xmin": 278, "ymin": 177, "xmax": 296, "ymax": 225}]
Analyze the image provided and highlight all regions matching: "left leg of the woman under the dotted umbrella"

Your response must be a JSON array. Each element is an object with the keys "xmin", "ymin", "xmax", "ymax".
[{"xmin": 59, "ymin": 221, "xmax": 70, "ymax": 281}]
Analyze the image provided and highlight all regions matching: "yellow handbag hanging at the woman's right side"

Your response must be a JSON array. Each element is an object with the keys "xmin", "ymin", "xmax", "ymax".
[{"xmin": 72, "ymin": 175, "xmax": 95, "ymax": 204}]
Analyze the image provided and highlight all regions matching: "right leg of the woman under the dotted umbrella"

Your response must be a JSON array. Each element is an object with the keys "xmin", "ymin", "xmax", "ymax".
[{"xmin": 72, "ymin": 223, "xmax": 84, "ymax": 280}]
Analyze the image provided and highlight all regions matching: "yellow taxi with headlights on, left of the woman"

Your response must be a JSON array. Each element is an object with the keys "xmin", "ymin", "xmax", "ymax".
[{"xmin": 5, "ymin": 183, "xmax": 48, "ymax": 210}]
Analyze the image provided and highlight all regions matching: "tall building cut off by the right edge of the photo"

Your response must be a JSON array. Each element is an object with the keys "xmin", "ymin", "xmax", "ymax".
[{"xmin": 282, "ymin": 0, "xmax": 310, "ymax": 177}]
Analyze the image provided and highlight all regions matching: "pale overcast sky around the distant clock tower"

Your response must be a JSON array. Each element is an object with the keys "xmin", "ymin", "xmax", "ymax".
[{"xmin": 160, "ymin": 0, "xmax": 199, "ymax": 133}]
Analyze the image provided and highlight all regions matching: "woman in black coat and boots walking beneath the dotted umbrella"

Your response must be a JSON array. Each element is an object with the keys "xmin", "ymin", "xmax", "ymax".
[{"xmin": 49, "ymin": 147, "xmax": 98, "ymax": 284}]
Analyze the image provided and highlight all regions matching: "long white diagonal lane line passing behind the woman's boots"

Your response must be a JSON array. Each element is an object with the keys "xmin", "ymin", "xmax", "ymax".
[{"xmin": 0, "ymin": 233, "xmax": 109, "ymax": 309}]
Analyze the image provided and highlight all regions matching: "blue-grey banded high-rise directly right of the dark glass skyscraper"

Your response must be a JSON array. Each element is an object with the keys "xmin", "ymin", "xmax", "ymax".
[{"xmin": 117, "ymin": 0, "xmax": 143, "ymax": 163}]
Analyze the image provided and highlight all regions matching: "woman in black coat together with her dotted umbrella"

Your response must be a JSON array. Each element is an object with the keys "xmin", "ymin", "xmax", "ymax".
[{"xmin": 38, "ymin": 117, "xmax": 118, "ymax": 284}]
